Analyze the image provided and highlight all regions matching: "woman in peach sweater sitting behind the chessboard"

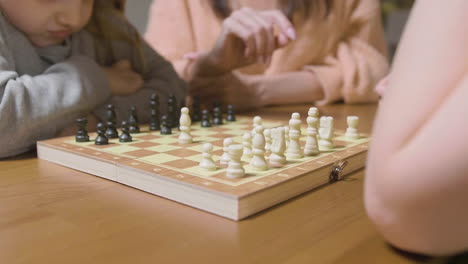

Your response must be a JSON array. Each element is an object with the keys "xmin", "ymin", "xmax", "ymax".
[{"xmin": 146, "ymin": 0, "xmax": 388, "ymax": 108}]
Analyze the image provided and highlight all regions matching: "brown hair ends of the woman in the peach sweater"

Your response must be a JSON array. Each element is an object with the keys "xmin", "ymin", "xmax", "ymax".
[{"xmin": 209, "ymin": 0, "xmax": 333, "ymax": 23}]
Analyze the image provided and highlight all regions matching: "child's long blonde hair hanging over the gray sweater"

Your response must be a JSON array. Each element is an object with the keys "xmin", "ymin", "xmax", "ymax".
[{"xmin": 86, "ymin": 0, "xmax": 146, "ymax": 74}]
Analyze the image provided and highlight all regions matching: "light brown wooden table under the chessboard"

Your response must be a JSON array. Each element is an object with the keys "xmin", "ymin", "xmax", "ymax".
[{"xmin": 0, "ymin": 105, "xmax": 442, "ymax": 264}]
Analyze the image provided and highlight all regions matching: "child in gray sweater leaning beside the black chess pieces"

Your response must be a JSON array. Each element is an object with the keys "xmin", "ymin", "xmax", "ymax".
[{"xmin": 0, "ymin": 0, "xmax": 185, "ymax": 158}]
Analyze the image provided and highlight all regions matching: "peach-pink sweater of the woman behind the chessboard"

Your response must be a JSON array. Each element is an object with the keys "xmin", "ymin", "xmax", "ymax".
[{"xmin": 145, "ymin": 0, "xmax": 388, "ymax": 104}]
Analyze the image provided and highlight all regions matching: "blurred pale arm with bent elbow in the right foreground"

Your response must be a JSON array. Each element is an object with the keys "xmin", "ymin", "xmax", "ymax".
[{"xmin": 365, "ymin": 0, "xmax": 468, "ymax": 256}]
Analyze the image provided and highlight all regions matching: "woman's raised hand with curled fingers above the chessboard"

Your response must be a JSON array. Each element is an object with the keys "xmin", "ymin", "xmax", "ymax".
[{"xmin": 198, "ymin": 8, "xmax": 296, "ymax": 73}]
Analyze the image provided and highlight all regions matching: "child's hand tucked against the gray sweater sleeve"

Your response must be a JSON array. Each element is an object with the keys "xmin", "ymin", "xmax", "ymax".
[{"xmin": 103, "ymin": 60, "xmax": 144, "ymax": 95}]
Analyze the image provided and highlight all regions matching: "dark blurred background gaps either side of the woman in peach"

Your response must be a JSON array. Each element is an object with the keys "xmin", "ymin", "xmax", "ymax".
[{"xmin": 126, "ymin": 0, "xmax": 414, "ymax": 57}]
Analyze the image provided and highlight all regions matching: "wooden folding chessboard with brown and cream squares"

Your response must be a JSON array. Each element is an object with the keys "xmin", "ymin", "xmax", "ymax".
[{"xmin": 37, "ymin": 117, "xmax": 369, "ymax": 220}]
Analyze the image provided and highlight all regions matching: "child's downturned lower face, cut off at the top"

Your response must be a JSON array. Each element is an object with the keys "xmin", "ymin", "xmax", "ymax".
[{"xmin": 0, "ymin": 0, "xmax": 94, "ymax": 47}]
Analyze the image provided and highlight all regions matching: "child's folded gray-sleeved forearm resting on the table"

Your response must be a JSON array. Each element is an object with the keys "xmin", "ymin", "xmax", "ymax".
[{"xmin": 0, "ymin": 56, "xmax": 110, "ymax": 158}]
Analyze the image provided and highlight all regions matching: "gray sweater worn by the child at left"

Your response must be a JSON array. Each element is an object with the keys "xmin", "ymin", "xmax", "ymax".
[{"xmin": 0, "ymin": 13, "xmax": 186, "ymax": 158}]
